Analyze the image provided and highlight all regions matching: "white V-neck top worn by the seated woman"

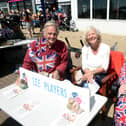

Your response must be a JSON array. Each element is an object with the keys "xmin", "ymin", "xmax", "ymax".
[{"xmin": 82, "ymin": 43, "xmax": 110, "ymax": 71}]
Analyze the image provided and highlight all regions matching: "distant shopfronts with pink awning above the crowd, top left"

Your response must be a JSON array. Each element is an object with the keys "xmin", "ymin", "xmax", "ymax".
[{"xmin": 0, "ymin": 0, "xmax": 58, "ymax": 14}]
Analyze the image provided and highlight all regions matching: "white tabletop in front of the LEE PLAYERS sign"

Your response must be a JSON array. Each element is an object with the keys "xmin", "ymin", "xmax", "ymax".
[{"xmin": 0, "ymin": 84, "xmax": 107, "ymax": 126}]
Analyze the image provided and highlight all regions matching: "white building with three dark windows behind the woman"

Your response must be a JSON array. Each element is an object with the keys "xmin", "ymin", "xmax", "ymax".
[{"xmin": 71, "ymin": 0, "xmax": 126, "ymax": 35}]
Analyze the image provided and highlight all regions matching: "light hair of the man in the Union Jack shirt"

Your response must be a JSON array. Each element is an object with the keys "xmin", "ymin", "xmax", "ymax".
[{"xmin": 43, "ymin": 20, "xmax": 59, "ymax": 35}]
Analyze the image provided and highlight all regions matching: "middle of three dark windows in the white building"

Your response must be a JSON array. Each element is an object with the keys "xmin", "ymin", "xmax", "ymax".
[{"xmin": 93, "ymin": 0, "xmax": 107, "ymax": 19}]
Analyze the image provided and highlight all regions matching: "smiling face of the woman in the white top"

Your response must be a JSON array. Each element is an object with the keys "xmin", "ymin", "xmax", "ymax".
[{"xmin": 87, "ymin": 29, "xmax": 98, "ymax": 44}]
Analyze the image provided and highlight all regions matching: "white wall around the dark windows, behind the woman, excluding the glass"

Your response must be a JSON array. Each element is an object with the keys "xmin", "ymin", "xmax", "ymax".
[{"xmin": 71, "ymin": 0, "xmax": 126, "ymax": 35}]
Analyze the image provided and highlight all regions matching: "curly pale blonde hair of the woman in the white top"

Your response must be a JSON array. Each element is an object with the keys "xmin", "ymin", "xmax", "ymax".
[{"xmin": 85, "ymin": 26, "xmax": 101, "ymax": 44}]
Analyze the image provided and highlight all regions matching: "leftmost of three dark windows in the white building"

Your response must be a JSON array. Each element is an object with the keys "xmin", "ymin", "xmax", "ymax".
[{"xmin": 78, "ymin": 0, "xmax": 90, "ymax": 18}]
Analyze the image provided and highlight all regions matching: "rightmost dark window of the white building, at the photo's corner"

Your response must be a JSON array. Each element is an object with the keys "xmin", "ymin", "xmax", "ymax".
[{"xmin": 110, "ymin": 0, "xmax": 126, "ymax": 19}]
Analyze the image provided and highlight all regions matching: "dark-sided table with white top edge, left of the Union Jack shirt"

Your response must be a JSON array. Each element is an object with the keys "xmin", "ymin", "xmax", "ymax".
[{"xmin": 0, "ymin": 39, "xmax": 35, "ymax": 64}]
